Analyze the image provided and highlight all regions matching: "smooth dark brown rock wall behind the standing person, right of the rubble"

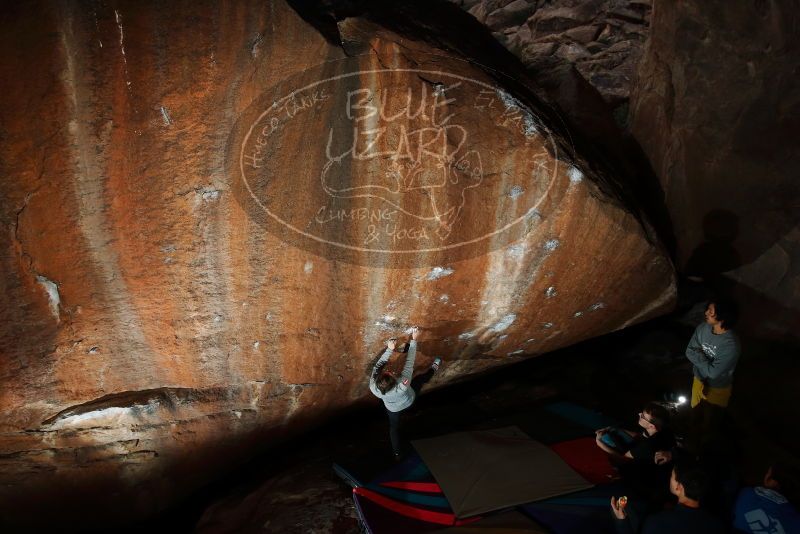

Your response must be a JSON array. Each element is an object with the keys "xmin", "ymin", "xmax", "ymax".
[{"xmin": 631, "ymin": 0, "xmax": 800, "ymax": 339}]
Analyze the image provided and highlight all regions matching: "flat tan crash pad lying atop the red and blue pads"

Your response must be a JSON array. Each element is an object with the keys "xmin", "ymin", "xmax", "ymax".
[{"xmin": 412, "ymin": 426, "xmax": 592, "ymax": 518}]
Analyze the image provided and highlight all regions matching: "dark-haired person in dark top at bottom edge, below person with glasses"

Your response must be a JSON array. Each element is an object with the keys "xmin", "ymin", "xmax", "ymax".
[{"xmin": 611, "ymin": 460, "xmax": 727, "ymax": 534}]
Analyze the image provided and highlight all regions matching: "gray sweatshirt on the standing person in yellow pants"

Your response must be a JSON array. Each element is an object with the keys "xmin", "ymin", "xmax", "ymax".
[{"xmin": 686, "ymin": 323, "xmax": 741, "ymax": 388}]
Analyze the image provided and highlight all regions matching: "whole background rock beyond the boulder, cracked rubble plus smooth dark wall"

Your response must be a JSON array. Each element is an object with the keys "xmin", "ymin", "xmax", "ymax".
[{"xmin": 453, "ymin": 0, "xmax": 800, "ymax": 339}]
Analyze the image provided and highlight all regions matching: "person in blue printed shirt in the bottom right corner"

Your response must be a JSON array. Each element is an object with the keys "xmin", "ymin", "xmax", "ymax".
[{"xmin": 733, "ymin": 465, "xmax": 800, "ymax": 534}]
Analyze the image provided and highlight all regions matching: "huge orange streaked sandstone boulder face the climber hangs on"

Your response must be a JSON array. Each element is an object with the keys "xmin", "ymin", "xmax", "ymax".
[{"xmin": 0, "ymin": 2, "xmax": 675, "ymax": 525}]
